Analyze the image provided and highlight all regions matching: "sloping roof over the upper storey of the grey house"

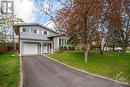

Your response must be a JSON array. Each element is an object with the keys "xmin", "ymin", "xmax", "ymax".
[{"xmin": 12, "ymin": 23, "xmax": 59, "ymax": 34}]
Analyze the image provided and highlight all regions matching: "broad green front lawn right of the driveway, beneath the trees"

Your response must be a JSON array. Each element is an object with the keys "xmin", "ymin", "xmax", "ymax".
[{"xmin": 50, "ymin": 51, "xmax": 130, "ymax": 83}]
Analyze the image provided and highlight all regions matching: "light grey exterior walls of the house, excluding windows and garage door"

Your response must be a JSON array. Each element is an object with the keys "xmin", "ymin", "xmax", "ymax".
[{"xmin": 20, "ymin": 26, "xmax": 68, "ymax": 55}]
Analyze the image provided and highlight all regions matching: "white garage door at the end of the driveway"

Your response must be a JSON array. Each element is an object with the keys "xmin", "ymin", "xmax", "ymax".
[{"xmin": 23, "ymin": 43, "xmax": 38, "ymax": 55}]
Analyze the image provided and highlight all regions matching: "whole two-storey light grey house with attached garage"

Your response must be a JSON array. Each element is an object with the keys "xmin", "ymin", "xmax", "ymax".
[{"xmin": 13, "ymin": 23, "xmax": 68, "ymax": 56}]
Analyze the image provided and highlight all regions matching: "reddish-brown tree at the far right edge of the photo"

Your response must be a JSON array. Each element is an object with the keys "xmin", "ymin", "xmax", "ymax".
[{"xmin": 106, "ymin": 0, "xmax": 130, "ymax": 53}]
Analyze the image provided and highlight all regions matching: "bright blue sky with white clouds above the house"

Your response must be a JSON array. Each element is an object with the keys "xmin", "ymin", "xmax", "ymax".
[{"xmin": 13, "ymin": 0, "xmax": 59, "ymax": 28}]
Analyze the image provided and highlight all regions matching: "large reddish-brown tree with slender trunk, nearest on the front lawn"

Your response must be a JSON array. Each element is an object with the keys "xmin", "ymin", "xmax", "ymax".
[{"xmin": 44, "ymin": 0, "xmax": 107, "ymax": 62}]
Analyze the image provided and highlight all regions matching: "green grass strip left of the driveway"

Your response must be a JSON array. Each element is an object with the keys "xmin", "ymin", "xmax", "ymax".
[{"xmin": 0, "ymin": 52, "xmax": 20, "ymax": 87}]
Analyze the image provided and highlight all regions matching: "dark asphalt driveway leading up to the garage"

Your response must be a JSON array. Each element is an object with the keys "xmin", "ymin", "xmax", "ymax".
[{"xmin": 22, "ymin": 56, "xmax": 129, "ymax": 87}]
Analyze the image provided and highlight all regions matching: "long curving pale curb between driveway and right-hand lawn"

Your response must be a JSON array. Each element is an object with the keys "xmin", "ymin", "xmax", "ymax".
[{"xmin": 42, "ymin": 55, "xmax": 129, "ymax": 86}]
